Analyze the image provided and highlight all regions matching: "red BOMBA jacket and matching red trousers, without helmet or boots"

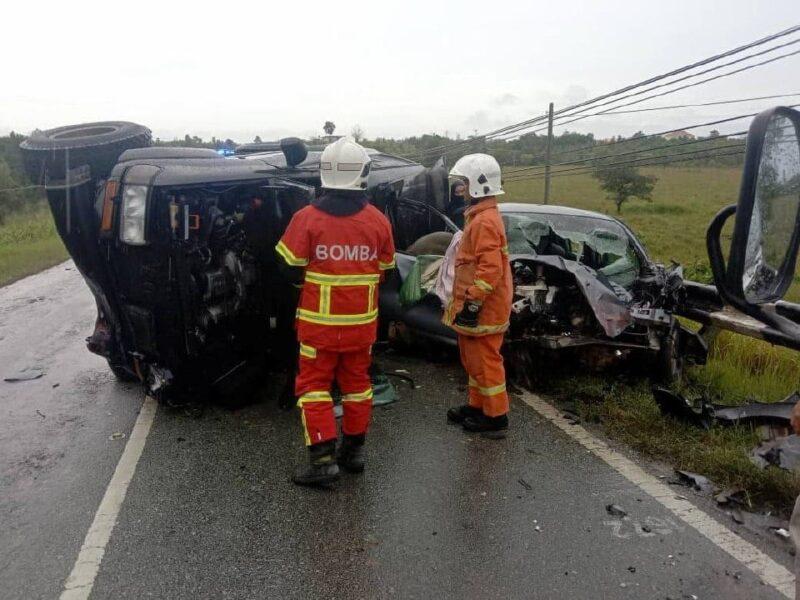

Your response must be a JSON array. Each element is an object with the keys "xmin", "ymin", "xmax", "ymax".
[{"xmin": 276, "ymin": 205, "xmax": 394, "ymax": 445}]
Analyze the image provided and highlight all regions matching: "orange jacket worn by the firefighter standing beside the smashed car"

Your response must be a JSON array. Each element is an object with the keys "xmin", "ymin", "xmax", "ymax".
[{"xmin": 443, "ymin": 198, "xmax": 514, "ymax": 335}]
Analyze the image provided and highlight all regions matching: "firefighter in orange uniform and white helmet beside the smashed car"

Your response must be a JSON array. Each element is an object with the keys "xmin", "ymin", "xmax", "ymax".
[{"xmin": 444, "ymin": 154, "xmax": 513, "ymax": 438}]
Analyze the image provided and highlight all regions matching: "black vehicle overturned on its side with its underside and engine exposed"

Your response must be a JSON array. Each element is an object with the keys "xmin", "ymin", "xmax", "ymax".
[{"xmin": 21, "ymin": 122, "xmax": 425, "ymax": 401}]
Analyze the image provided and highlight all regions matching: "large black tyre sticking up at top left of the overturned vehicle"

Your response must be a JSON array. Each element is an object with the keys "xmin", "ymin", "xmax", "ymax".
[{"xmin": 19, "ymin": 121, "xmax": 152, "ymax": 183}]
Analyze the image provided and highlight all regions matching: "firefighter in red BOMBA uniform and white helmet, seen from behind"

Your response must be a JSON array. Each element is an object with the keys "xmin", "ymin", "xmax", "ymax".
[{"xmin": 276, "ymin": 138, "xmax": 394, "ymax": 485}]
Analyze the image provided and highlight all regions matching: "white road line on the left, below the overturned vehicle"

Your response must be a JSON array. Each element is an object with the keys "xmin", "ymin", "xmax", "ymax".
[{"xmin": 60, "ymin": 396, "xmax": 158, "ymax": 600}]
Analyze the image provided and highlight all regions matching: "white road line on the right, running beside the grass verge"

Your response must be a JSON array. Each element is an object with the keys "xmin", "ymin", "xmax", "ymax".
[{"xmin": 522, "ymin": 392, "xmax": 795, "ymax": 598}]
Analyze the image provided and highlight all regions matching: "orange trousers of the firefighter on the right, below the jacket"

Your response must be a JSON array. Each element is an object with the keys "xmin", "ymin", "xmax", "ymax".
[{"xmin": 458, "ymin": 333, "xmax": 508, "ymax": 417}]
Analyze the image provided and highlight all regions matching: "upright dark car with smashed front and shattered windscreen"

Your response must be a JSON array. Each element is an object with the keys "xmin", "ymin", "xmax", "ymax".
[{"xmin": 381, "ymin": 197, "xmax": 707, "ymax": 381}]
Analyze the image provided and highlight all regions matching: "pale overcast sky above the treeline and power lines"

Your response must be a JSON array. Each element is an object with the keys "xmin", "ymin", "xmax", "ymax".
[{"xmin": 0, "ymin": 0, "xmax": 800, "ymax": 142}]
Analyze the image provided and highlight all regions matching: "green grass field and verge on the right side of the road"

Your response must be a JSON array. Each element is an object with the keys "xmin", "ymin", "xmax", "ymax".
[{"xmin": 504, "ymin": 167, "xmax": 800, "ymax": 511}]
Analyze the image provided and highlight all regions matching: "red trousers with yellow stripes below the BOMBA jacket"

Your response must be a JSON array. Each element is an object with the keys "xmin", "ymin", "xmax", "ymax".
[{"xmin": 294, "ymin": 342, "xmax": 372, "ymax": 446}]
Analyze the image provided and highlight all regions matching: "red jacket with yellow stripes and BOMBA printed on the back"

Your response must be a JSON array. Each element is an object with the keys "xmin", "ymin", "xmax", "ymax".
[{"xmin": 276, "ymin": 204, "xmax": 394, "ymax": 352}]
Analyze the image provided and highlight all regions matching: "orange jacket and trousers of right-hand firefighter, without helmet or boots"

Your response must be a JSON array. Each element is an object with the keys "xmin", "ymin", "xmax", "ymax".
[{"xmin": 443, "ymin": 198, "xmax": 513, "ymax": 417}]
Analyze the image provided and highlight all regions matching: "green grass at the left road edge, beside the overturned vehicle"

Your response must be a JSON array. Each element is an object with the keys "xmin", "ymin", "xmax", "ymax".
[{"xmin": 0, "ymin": 207, "xmax": 68, "ymax": 286}]
